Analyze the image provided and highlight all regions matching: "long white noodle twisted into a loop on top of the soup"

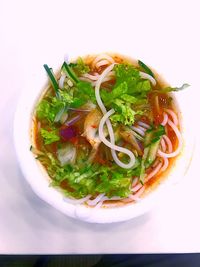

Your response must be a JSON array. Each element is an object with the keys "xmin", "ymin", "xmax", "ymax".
[{"xmin": 95, "ymin": 64, "xmax": 135, "ymax": 169}]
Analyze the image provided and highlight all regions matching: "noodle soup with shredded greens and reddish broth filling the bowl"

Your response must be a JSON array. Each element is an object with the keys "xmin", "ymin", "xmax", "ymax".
[{"xmin": 31, "ymin": 54, "xmax": 187, "ymax": 208}]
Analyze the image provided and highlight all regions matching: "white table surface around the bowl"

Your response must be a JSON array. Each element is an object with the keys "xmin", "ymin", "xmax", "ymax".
[{"xmin": 0, "ymin": 0, "xmax": 200, "ymax": 254}]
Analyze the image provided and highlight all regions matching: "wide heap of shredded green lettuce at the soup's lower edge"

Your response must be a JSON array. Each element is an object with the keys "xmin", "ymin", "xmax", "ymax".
[{"xmin": 40, "ymin": 153, "xmax": 140, "ymax": 198}]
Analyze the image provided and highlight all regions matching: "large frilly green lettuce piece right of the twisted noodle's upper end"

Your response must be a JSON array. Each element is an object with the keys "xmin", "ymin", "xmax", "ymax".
[{"xmin": 101, "ymin": 64, "xmax": 151, "ymax": 125}]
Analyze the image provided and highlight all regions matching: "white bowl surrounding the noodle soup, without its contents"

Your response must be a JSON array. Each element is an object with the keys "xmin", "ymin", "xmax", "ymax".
[{"xmin": 14, "ymin": 54, "xmax": 194, "ymax": 223}]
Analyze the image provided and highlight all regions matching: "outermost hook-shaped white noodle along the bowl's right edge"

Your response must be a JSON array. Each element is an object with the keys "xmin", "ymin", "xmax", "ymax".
[{"xmin": 158, "ymin": 119, "xmax": 183, "ymax": 158}]
